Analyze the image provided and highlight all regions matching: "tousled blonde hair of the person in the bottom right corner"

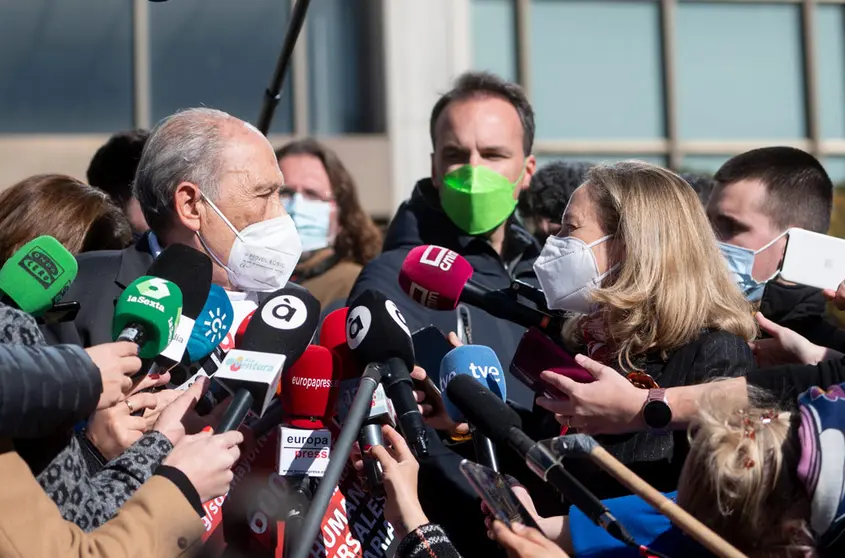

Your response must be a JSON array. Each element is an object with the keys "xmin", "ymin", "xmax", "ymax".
[{"xmin": 678, "ymin": 401, "xmax": 814, "ymax": 557}]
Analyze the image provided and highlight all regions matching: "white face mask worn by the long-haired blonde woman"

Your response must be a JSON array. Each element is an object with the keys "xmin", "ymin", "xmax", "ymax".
[{"xmin": 534, "ymin": 235, "xmax": 616, "ymax": 314}]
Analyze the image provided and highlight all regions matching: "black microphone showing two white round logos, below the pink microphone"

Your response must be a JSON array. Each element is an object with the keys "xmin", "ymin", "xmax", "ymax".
[{"xmin": 346, "ymin": 289, "xmax": 428, "ymax": 459}]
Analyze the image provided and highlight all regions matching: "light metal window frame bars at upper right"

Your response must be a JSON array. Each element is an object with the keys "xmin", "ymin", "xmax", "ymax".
[{"xmin": 511, "ymin": 0, "xmax": 845, "ymax": 169}]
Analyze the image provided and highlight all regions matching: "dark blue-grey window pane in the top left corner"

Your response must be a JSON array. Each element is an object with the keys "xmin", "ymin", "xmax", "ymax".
[{"xmin": 0, "ymin": 0, "xmax": 132, "ymax": 133}]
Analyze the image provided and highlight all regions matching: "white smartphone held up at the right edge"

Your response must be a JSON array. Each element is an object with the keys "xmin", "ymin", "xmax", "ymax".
[{"xmin": 780, "ymin": 229, "xmax": 845, "ymax": 290}]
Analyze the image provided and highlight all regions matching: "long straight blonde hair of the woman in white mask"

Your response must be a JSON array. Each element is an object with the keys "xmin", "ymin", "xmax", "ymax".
[{"xmin": 565, "ymin": 161, "xmax": 757, "ymax": 370}]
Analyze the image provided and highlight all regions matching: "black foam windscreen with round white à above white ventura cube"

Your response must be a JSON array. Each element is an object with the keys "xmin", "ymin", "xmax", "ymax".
[{"xmin": 236, "ymin": 284, "xmax": 320, "ymax": 369}]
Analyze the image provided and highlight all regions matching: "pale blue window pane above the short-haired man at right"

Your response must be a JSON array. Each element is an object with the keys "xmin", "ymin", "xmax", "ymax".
[{"xmin": 675, "ymin": 2, "xmax": 806, "ymax": 139}]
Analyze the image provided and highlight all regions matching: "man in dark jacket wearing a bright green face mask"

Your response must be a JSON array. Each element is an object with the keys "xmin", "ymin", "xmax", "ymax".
[{"xmin": 350, "ymin": 73, "xmax": 540, "ymax": 556}]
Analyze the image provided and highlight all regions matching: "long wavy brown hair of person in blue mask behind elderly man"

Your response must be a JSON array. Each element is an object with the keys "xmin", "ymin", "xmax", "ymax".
[{"xmin": 276, "ymin": 138, "xmax": 382, "ymax": 265}]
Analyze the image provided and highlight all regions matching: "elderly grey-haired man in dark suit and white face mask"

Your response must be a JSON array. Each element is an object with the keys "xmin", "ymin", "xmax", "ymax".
[{"xmin": 46, "ymin": 108, "xmax": 302, "ymax": 354}]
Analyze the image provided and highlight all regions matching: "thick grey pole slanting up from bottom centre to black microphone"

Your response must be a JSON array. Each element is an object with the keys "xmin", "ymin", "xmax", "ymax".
[{"xmin": 285, "ymin": 366, "xmax": 385, "ymax": 558}]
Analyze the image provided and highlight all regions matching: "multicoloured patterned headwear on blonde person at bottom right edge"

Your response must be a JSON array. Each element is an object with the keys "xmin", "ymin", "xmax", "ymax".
[{"xmin": 798, "ymin": 384, "xmax": 845, "ymax": 548}]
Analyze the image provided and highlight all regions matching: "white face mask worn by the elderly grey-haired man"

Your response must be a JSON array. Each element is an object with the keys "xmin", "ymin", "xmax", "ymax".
[{"xmin": 197, "ymin": 195, "xmax": 302, "ymax": 292}]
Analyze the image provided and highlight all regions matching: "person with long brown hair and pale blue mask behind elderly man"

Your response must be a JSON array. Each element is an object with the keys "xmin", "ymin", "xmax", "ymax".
[{"xmin": 276, "ymin": 139, "xmax": 382, "ymax": 310}]
